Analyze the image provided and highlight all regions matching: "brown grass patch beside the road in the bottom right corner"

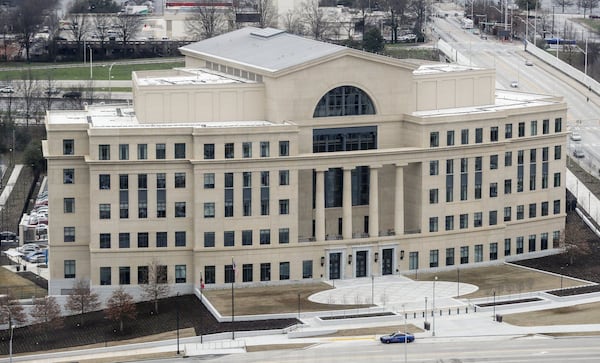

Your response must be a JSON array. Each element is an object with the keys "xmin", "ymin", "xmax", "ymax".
[{"xmin": 503, "ymin": 303, "xmax": 600, "ymax": 326}]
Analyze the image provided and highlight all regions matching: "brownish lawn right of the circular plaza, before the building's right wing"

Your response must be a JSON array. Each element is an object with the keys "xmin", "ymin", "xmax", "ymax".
[{"xmin": 408, "ymin": 264, "xmax": 586, "ymax": 299}]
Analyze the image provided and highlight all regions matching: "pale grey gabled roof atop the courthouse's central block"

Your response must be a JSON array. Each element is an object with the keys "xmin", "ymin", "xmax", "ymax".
[{"xmin": 180, "ymin": 27, "xmax": 348, "ymax": 72}]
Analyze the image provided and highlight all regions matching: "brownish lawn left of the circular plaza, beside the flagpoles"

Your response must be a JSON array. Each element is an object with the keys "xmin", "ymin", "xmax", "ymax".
[{"xmin": 204, "ymin": 283, "xmax": 369, "ymax": 315}]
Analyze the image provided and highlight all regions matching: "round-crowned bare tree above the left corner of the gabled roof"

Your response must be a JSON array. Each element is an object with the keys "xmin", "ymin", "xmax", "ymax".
[{"xmin": 185, "ymin": 5, "xmax": 227, "ymax": 40}]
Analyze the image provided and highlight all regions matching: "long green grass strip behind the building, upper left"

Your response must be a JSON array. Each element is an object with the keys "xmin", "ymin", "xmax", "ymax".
[{"xmin": 0, "ymin": 61, "xmax": 184, "ymax": 81}]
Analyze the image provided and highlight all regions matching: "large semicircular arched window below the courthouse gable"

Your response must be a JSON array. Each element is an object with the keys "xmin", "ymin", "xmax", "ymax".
[{"xmin": 313, "ymin": 86, "xmax": 375, "ymax": 117}]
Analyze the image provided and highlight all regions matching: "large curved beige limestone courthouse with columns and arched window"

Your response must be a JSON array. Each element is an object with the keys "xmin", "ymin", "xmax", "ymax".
[{"xmin": 43, "ymin": 27, "xmax": 567, "ymax": 295}]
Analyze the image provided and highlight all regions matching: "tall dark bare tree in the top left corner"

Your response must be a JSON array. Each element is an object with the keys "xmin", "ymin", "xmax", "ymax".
[{"xmin": 14, "ymin": 0, "xmax": 57, "ymax": 62}]
